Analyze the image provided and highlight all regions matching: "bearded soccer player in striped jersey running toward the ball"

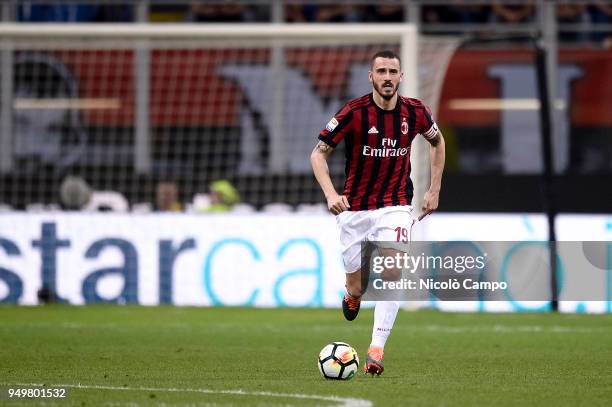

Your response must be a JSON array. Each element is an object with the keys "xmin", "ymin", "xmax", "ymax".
[{"xmin": 310, "ymin": 51, "xmax": 445, "ymax": 375}]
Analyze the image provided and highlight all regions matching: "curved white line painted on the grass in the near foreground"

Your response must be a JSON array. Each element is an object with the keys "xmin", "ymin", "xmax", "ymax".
[{"xmin": 2, "ymin": 383, "xmax": 373, "ymax": 407}]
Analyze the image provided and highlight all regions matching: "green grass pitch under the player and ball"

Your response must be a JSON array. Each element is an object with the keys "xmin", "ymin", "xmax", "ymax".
[{"xmin": 0, "ymin": 306, "xmax": 612, "ymax": 407}]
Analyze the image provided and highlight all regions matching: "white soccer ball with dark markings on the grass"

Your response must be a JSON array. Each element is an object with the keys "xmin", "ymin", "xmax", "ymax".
[{"xmin": 318, "ymin": 342, "xmax": 359, "ymax": 380}]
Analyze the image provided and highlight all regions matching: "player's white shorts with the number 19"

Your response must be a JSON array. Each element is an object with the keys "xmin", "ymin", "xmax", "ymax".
[{"xmin": 336, "ymin": 205, "xmax": 415, "ymax": 273}]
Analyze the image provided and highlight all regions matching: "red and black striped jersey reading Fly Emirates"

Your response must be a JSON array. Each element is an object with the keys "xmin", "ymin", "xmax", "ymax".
[{"xmin": 319, "ymin": 93, "xmax": 438, "ymax": 211}]
